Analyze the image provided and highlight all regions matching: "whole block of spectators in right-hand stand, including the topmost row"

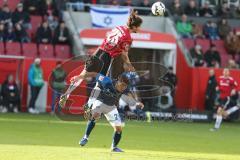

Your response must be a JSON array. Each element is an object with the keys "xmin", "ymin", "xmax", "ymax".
[{"xmin": 170, "ymin": 0, "xmax": 240, "ymax": 68}]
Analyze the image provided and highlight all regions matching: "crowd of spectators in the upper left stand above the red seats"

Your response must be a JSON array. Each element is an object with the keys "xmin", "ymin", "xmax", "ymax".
[{"xmin": 0, "ymin": 0, "xmax": 69, "ymax": 44}]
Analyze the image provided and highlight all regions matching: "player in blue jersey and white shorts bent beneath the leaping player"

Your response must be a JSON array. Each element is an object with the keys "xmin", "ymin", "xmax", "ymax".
[{"xmin": 72, "ymin": 74, "xmax": 143, "ymax": 152}]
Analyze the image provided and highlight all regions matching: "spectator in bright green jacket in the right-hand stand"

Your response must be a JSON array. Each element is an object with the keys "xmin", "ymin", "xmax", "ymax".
[{"xmin": 177, "ymin": 14, "xmax": 192, "ymax": 38}]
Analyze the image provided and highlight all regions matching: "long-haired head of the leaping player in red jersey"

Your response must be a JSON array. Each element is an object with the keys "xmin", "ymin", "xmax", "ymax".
[{"xmin": 127, "ymin": 10, "xmax": 142, "ymax": 33}]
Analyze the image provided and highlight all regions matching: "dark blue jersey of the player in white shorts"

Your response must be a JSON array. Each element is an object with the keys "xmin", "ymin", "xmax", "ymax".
[{"xmin": 96, "ymin": 74, "xmax": 122, "ymax": 106}]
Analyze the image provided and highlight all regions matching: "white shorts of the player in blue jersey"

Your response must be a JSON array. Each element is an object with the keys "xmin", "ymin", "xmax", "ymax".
[{"xmin": 91, "ymin": 100, "xmax": 122, "ymax": 127}]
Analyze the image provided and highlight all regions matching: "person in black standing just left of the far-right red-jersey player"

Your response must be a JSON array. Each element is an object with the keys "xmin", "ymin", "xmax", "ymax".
[{"xmin": 205, "ymin": 69, "xmax": 217, "ymax": 112}]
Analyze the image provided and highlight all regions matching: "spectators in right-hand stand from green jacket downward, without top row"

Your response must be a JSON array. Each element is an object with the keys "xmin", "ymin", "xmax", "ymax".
[{"xmin": 176, "ymin": 14, "xmax": 240, "ymax": 67}]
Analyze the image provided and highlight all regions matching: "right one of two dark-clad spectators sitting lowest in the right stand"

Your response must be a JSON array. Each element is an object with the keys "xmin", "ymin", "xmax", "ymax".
[{"xmin": 204, "ymin": 44, "xmax": 221, "ymax": 68}]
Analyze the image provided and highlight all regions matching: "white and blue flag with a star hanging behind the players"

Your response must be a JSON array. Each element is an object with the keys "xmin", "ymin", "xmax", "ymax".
[{"xmin": 90, "ymin": 7, "xmax": 130, "ymax": 28}]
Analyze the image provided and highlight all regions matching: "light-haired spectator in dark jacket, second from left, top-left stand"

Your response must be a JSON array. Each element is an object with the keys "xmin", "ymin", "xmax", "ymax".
[{"xmin": 12, "ymin": 3, "xmax": 32, "ymax": 29}]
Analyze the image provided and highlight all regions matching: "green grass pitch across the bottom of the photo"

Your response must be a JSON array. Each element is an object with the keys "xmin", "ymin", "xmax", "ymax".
[{"xmin": 0, "ymin": 114, "xmax": 240, "ymax": 160}]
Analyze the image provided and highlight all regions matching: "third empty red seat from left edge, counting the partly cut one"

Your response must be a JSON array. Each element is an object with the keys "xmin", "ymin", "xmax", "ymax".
[{"xmin": 22, "ymin": 43, "xmax": 38, "ymax": 58}]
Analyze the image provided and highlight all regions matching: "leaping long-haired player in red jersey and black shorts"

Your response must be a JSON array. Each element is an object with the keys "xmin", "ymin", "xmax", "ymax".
[{"xmin": 59, "ymin": 11, "xmax": 142, "ymax": 107}]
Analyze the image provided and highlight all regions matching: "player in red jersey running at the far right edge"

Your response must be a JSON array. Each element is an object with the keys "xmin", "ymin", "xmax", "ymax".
[{"xmin": 211, "ymin": 68, "xmax": 239, "ymax": 131}]
